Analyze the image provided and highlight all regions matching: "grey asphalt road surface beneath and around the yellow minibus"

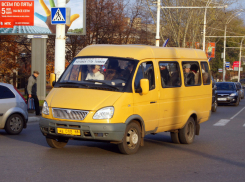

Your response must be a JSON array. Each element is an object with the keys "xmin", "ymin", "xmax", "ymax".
[{"xmin": 0, "ymin": 99, "xmax": 245, "ymax": 182}]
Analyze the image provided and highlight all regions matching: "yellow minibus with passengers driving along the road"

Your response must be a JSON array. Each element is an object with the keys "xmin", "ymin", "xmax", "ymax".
[{"xmin": 40, "ymin": 45, "xmax": 212, "ymax": 154}]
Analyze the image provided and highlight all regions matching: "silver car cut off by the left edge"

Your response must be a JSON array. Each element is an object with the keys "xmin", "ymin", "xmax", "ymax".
[{"xmin": 0, "ymin": 83, "xmax": 28, "ymax": 135}]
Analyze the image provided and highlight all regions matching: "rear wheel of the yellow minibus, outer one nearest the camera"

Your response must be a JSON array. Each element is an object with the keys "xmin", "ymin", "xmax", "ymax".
[{"xmin": 179, "ymin": 117, "xmax": 196, "ymax": 144}]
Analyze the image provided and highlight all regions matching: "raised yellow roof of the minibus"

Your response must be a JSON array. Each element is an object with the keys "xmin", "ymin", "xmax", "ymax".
[{"xmin": 76, "ymin": 44, "xmax": 207, "ymax": 60}]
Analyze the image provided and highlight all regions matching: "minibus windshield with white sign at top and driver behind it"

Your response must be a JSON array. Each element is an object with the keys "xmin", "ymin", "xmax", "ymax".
[{"xmin": 58, "ymin": 57, "xmax": 138, "ymax": 91}]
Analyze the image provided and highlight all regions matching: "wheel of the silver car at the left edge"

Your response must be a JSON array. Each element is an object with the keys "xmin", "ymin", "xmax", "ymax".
[{"xmin": 5, "ymin": 114, "xmax": 24, "ymax": 135}]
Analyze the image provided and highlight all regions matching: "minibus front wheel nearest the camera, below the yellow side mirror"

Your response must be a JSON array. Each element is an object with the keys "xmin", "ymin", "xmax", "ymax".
[{"xmin": 118, "ymin": 121, "xmax": 141, "ymax": 155}]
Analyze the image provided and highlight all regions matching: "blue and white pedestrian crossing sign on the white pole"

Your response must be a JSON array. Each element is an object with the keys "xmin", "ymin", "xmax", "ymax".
[{"xmin": 51, "ymin": 7, "xmax": 66, "ymax": 24}]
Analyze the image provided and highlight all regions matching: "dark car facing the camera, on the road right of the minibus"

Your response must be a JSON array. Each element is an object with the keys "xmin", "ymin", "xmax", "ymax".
[{"xmin": 216, "ymin": 82, "xmax": 241, "ymax": 106}]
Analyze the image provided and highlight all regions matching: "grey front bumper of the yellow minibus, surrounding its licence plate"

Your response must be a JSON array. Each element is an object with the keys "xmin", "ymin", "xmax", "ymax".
[{"xmin": 39, "ymin": 118, "xmax": 126, "ymax": 142}]
